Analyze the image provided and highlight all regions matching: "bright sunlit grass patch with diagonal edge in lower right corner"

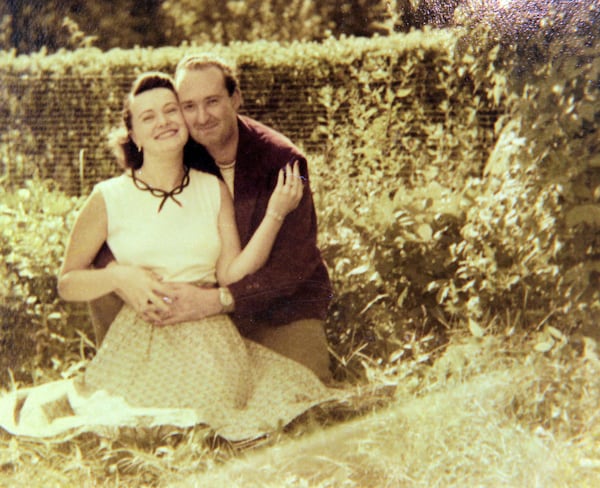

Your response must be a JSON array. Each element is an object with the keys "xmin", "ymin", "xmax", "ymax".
[{"xmin": 177, "ymin": 338, "xmax": 600, "ymax": 487}]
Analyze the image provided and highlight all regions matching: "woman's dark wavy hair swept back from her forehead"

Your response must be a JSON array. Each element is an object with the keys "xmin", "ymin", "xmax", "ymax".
[{"xmin": 108, "ymin": 71, "xmax": 177, "ymax": 169}]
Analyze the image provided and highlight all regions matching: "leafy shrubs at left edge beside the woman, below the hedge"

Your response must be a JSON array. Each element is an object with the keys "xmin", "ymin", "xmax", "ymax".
[{"xmin": 0, "ymin": 179, "xmax": 90, "ymax": 384}]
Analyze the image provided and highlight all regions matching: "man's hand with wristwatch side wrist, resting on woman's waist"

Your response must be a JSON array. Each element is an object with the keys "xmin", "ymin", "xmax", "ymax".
[{"xmin": 153, "ymin": 283, "xmax": 222, "ymax": 326}]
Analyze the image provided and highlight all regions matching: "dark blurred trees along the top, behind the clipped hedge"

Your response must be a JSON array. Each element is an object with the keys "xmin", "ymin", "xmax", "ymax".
[{"xmin": 0, "ymin": 0, "xmax": 460, "ymax": 53}]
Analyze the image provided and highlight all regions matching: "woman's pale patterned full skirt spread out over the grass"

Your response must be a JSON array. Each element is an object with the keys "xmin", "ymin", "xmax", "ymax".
[{"xmin": 0, "ymin": 306, "xmax": 340, "ymax": 441}]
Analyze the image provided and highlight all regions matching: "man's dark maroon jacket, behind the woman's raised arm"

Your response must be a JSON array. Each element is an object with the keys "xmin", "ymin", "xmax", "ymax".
[{"xmin": 186, "ymin": 116, "xmax": 332, "ymax": 330}]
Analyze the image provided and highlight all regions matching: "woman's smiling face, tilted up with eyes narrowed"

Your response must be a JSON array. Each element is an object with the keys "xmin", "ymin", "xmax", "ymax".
[{"xmin": 130, "ymin": 88, "xmax": 188, "ymax": 154}]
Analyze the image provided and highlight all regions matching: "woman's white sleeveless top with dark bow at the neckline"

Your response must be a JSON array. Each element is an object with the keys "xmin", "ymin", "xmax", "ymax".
[{"xmin": 94, "ymin": 169, "xmax": 221, "ymax": 283}]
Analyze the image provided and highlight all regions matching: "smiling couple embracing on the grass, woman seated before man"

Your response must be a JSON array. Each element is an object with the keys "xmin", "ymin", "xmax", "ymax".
[{"xmin": 0, "ymin": 55, "xmax": 339, "ymax": 440}]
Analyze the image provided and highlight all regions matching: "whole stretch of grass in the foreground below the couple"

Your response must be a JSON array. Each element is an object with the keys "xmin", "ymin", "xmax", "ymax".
[{"xmin": 0, "ymin": 330, "xmax": 600, "ymax": 488}]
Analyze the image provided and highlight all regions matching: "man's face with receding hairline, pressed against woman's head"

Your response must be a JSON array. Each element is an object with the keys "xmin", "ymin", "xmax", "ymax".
[{"xmin": 177, "ymin": 66, "xmax": 241, "ymax": 154}]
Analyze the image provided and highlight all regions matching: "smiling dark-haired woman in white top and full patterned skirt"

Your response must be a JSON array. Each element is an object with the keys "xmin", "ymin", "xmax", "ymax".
[{"xmin": 0, "ymin": 73, "xmax": 332, "ymax": 440}]
